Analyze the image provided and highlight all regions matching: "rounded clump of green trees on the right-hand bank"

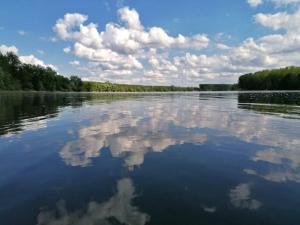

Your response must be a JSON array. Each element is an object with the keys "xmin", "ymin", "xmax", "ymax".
[{"xmin": 239, "ymin": 67, "xmax": 300, "ymax": 90}]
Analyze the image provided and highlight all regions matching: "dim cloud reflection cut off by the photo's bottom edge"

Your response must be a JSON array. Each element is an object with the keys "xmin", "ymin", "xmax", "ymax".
[{"xmin": 38, "ymin": 178, "xmax": 150, "ymax": 225}]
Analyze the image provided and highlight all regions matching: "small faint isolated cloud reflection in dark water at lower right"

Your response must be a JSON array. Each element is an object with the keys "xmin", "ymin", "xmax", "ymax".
[{"xmin": 230, "ymin": 184, "xmax": 262, "ymax": 210}]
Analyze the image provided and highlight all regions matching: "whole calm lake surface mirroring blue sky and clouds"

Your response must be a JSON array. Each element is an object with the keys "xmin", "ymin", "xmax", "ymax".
[{"xmin": 0, "ymin": 93, "xmax": 300, "ymax": 225}]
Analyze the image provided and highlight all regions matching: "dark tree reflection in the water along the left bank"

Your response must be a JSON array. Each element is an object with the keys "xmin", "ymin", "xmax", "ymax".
[{"xmin": 0, "ymin": 92, "xmax": 142, "ymax": 137}]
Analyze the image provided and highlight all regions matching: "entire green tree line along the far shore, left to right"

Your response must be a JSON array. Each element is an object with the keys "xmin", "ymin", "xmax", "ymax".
[{"xmin": 0, "ymin": 53, "xmax": 300, "ymax": 92}]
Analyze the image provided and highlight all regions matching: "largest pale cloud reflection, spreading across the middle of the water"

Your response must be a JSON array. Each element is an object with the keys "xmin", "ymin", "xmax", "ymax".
[{"xmin": 60, "ymin": 95, "xmax": 300, "ymax": 177}]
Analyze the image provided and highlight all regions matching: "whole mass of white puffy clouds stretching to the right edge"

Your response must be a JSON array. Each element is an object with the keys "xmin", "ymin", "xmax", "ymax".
[{"xmin": 50, "ymin": 4, "xmax": 300, "ymax": 85}]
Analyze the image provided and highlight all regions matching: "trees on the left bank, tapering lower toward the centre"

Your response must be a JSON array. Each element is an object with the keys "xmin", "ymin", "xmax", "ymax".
[{"xmin": 0, "ymin": 53, "xmax": 199, "ymax": 92}]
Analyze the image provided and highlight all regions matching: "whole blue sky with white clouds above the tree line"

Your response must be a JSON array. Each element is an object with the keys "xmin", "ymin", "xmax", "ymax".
[{"xmin": 0, "ymin": 0, "xmax": 300, "ymax": 85}]
